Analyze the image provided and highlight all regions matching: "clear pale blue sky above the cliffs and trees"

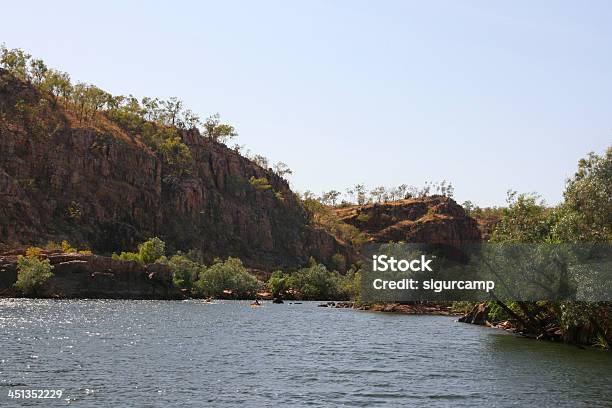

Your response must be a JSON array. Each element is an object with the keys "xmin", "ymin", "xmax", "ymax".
[{"xmin": 0, "ymin": 0, "xmax": 612, "ymax": 205}]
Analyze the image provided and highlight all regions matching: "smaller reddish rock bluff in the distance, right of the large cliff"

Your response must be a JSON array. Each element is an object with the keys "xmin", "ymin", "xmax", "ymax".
[{"xmin": 336, "ymin": 196, "xmax": 480, "ymax": 246}]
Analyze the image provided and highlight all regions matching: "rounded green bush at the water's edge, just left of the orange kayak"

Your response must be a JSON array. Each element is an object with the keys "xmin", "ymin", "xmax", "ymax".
[{"xmin": 194, "ymin": 257, "xmax": 259, "ymax": 298}]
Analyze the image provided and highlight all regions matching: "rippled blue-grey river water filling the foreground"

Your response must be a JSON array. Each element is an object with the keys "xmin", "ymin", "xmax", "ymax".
[{"xmin": 0, "ymin": 299, "xmax": 612, "ymax": 407}]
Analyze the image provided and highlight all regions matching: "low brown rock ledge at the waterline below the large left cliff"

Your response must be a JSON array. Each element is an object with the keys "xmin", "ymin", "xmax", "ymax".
[{"xmin": 0, "ymin": 252, "xmax": 182, "ymax": 299}]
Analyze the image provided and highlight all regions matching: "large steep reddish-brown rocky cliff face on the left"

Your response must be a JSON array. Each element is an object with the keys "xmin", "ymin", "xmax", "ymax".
[{"xmin": 0, "ymin": 70, "xmax": 351, "ymax": 270}]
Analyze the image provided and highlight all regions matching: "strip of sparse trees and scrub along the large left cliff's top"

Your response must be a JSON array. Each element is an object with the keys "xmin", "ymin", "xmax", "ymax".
[{"xmin": 0, "ymin": 44, "xmax": 292, "ymax": 181}]
